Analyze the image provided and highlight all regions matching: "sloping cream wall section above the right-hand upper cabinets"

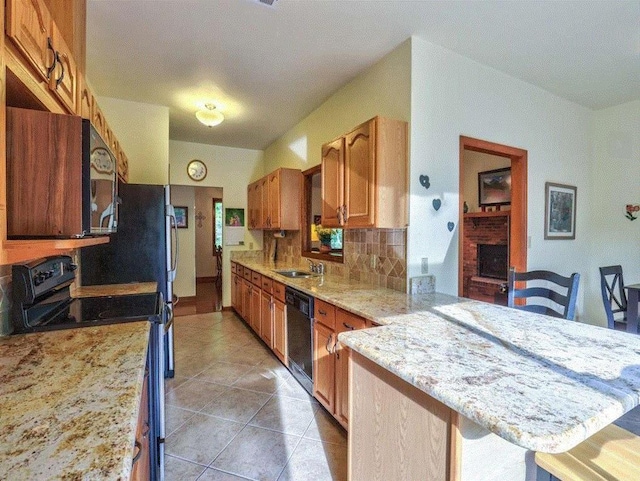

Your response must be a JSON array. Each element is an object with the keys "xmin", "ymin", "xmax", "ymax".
[{"xmin": 264, "ymin": 40, "xmax": 411, "ymax": 172}]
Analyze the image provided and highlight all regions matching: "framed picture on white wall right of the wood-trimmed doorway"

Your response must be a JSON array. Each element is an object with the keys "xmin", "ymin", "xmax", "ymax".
[{"xmin": 544, "ymin": 182, "xmax": 577, "ymax": 239}]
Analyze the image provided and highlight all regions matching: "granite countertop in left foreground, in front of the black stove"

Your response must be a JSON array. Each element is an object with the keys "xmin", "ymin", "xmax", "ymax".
[{"xmin": 0, "ymin": 321, "xmax": 150, "ymax": 480}]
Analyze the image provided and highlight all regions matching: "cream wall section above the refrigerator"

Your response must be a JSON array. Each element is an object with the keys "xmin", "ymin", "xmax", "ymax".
[{"xmin": 98, "ymin": 97, "xmax": 169, "ymax": 185}]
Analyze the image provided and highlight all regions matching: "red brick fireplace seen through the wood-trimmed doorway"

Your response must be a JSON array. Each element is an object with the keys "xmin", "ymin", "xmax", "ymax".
[{"xmin": 462, "ymin": 211, "xmax": 510, "ymax": 305}]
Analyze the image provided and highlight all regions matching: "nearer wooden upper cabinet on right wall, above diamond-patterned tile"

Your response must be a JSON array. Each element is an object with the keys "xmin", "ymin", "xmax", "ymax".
[{"xmin": 322, "ymin": 117, "xmax": 408, "ymax": 229}]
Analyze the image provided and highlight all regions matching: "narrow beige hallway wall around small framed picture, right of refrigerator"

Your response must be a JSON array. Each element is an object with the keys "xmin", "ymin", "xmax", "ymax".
[{"xmin": 171, "ymin": 185, "xmax": 196, "ymax": 297}]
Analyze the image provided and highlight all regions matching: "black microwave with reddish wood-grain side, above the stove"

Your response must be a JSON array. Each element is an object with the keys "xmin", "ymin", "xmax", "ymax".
[{"xmin": 7, "ymin": 107, "xmax": 118, "ymax": 239}]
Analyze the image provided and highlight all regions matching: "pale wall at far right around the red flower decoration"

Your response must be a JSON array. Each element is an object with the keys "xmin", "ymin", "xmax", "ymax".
[{"xmin": 578, "ymin": 100, "xmax": 640, "ymax": 325}]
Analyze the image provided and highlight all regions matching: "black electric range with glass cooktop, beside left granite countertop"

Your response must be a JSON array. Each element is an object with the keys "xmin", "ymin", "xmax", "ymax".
[{"xmin": 12, "ymin": 256, "xmax": 167, "ymax": 480}]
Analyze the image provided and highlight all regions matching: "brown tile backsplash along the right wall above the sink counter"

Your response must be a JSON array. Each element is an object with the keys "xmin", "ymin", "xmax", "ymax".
[{"xmin": 263, "ymin": 229, "xmax": 407, "ymax": 292}]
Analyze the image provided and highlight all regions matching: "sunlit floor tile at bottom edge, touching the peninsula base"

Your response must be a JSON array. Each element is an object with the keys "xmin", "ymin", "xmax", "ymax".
[{"xmin": 278, "ymin": 439, "xmax": 347, "ymax": 481}]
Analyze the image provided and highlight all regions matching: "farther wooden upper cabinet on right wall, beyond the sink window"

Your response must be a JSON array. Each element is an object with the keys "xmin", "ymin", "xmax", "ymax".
[{"xmin": 247, "ymin": 168, "xmax": 302, "ymax": 230}]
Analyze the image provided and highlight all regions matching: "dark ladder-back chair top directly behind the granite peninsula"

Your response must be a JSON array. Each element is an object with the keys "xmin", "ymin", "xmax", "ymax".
[{"xmin": 507, "ymin": 267, "xmax": 580, "ymax": 320}]
